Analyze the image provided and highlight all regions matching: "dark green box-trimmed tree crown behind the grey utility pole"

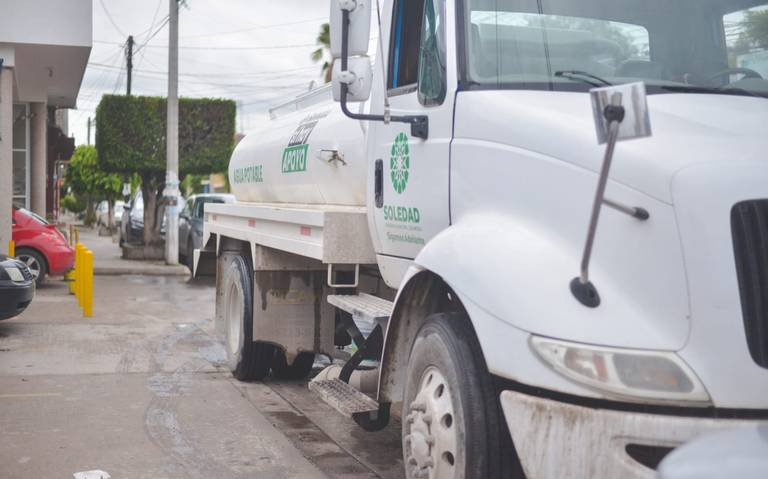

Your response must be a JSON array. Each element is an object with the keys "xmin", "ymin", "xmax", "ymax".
[{"xmin": 96, "ymin": 95, "xmax": 236, "ymax": 178}]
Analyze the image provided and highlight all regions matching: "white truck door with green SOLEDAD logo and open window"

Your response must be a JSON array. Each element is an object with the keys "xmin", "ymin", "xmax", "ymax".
[{"xmin": 369, "ymin": 0, "xmax": 456, "ymax": 258}]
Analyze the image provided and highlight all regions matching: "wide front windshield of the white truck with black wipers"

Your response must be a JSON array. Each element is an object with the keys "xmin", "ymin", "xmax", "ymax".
[{"xmin": 460, "ymin": 0, "xmax": 768, "ymax": 97}]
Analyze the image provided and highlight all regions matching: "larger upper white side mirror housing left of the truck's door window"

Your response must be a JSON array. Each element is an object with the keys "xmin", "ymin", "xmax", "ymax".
[{"xmin": 330, "ymin": 0, "xmax": 373, "ymax": 59}]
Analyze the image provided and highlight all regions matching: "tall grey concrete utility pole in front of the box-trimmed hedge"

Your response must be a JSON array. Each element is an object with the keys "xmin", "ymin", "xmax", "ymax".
[{"xmin": 163, "ymin": 0, "xmax": 181, "ymax": 265}]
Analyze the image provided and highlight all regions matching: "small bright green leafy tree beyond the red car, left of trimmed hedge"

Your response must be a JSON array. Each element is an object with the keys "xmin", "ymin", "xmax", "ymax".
[{"xmin": 66, "ymin": 145, "xmax": 123, "ymax": 231}]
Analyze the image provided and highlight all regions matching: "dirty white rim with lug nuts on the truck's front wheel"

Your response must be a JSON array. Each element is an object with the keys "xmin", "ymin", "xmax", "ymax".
[{"xmin": 405, "ymin": 366, "xmax": 459, "ymax": 479}]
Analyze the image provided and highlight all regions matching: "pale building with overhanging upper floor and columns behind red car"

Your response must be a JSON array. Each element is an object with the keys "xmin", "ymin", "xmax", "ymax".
[{"xmin": 0, "ymin": 0, "xmax": 93, "ymax": 253}]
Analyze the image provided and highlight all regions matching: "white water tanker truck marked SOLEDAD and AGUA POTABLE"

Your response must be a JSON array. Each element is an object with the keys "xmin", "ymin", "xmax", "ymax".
[{"xmin": 195, "ymin": 0, "xmax": 768, "ymax": 479}]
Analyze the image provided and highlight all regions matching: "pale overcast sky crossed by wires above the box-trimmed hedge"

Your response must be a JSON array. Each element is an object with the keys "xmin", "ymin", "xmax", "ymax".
[{"xmin": 69, "ymin": 0, "xmax": 329, "ymax": 145}]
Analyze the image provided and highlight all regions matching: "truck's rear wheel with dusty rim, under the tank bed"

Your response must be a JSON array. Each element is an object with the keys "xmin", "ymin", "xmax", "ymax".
[{"xmin": 224, "ymin": 256, "xmax": 275, "ymax": 381}]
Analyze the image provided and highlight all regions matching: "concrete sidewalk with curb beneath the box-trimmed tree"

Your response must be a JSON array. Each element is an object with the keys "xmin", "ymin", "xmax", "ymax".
[{"xmin": 78, "ymin": 226, "xmax": 189, "ymax": 276}]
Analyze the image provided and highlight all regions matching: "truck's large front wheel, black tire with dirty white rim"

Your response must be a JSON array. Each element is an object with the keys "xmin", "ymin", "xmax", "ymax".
[{"xmin": 402, "ymin": 313, "xmax": 525, "ymax": 479}]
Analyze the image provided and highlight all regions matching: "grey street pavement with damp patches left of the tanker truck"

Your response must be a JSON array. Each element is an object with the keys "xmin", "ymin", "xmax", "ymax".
[{"xmin": 0, "ymin": 276, "xmax": 403, "ymax": 479}]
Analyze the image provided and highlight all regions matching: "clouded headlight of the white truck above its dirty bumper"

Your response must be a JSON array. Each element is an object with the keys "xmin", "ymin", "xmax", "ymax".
[{"xmin": 530, "ymin": 336, "xmax": 711, "ymax": 404}]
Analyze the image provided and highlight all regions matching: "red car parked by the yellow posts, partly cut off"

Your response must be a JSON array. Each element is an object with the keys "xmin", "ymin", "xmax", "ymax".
[{"xmin": 13, "ymin": 208, "xmax": 75, "ymax": 285}]
